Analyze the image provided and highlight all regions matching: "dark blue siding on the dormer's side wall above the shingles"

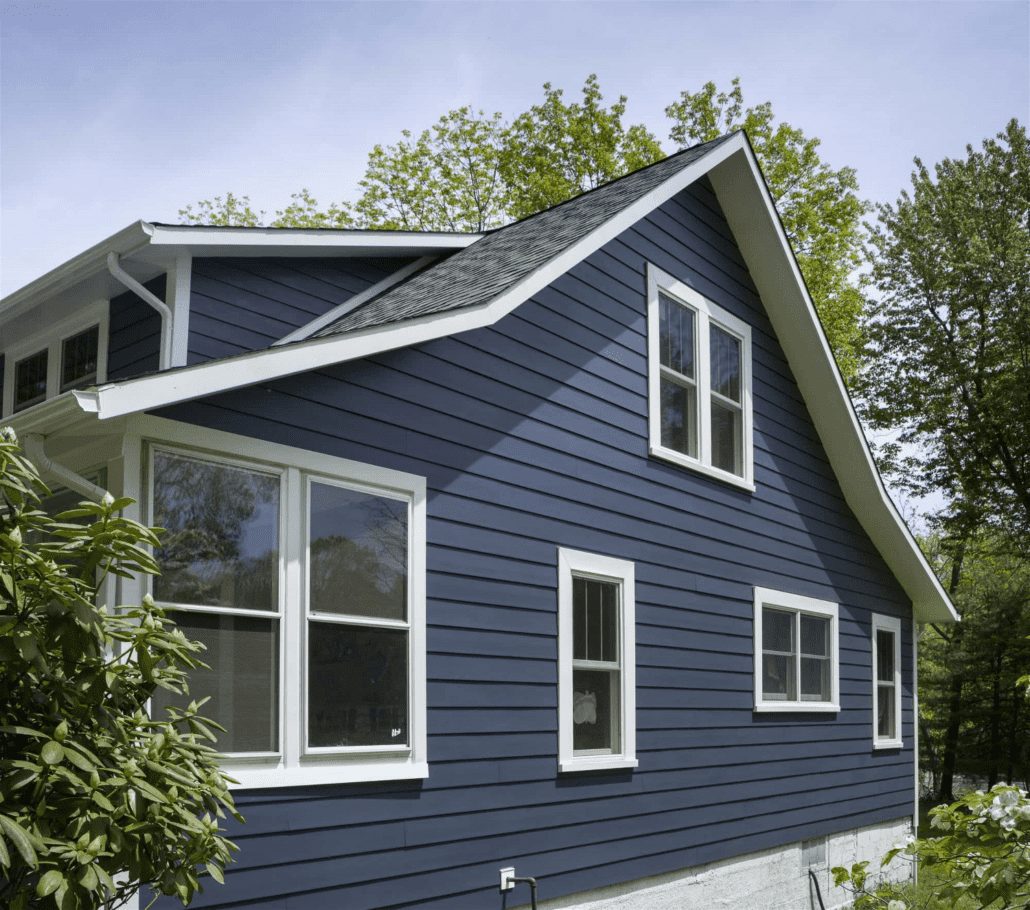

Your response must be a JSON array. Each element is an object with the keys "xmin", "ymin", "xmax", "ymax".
[{"xmin": 187, "ymin": 258, "xmax": 411, "ymax": 364}]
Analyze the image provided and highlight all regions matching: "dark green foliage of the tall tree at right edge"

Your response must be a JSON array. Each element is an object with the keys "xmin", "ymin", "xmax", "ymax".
[{"xmin": 861, "ymin": 120, "xmax": 1030, "ymax": 550}]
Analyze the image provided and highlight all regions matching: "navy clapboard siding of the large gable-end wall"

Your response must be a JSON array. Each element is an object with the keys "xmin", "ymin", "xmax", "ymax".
[{"xmin": 150, "ymin": 183, "xmax": 914, "ymax": 910}]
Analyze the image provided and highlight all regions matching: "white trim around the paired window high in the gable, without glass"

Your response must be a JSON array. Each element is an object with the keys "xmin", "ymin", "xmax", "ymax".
[{"xmin": 647, "ymin": 263, "xmax": 755, "ymax": 492}]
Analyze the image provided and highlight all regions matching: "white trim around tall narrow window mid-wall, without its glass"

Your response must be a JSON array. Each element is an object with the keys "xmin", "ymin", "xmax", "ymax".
[{"xmin": 558, "ymin": 547, "xmax": 638, "ymax": 773}]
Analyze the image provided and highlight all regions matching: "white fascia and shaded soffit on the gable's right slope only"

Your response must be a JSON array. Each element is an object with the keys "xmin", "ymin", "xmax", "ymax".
[{"xmin": 709, "ymin": 143, "xmax": 959, "ymax": 622}]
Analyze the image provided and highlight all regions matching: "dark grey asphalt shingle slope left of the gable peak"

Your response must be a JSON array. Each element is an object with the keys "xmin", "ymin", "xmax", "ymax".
[{"xmin": 316, "ymin": 136, "xmax": 727, "ymax": 337}]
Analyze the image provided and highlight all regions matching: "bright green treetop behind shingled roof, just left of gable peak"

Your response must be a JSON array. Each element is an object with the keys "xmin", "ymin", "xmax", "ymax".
[{"xmin": 501, "ymin": 73, "xmax": 664, "ymax": 218}]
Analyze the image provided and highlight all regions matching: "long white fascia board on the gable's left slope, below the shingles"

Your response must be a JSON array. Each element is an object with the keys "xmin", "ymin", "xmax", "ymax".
[{"xmin": 88, "ymin": 133, "xmax": 746, "ymax": 419}]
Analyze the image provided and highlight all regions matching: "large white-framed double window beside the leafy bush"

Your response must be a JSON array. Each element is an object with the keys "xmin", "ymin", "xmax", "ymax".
[{"xmin": 143, "ymin": 422, "xmax": 428, "ymax": 786}]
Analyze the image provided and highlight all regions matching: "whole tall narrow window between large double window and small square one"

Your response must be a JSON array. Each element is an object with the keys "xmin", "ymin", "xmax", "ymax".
[{"xmin": 558, "ymin": 547, "xmax": 637, "ymax": 772}]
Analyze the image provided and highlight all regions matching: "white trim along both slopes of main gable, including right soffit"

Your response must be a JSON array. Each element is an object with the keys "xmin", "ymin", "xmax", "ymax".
[{"xmin": 6, "ymin": 133, "xmax": 958, "ymax": 622}]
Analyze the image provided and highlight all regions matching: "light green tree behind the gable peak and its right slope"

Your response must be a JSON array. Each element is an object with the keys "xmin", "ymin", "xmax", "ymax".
[{"xmin": 665, "ymin": 73, "xmax": 868, "ymax": 380}]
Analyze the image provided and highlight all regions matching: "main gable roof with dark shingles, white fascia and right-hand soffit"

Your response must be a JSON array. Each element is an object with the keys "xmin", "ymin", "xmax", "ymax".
[{"xmin": 4, "ymin": 133, "xmax": 958, "ymax": 622}]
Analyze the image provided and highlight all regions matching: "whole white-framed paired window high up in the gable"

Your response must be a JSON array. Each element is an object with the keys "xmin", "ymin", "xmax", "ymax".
[{"xmin": 647, "ymin": 264, "xmax": 754, "ymax": 490}]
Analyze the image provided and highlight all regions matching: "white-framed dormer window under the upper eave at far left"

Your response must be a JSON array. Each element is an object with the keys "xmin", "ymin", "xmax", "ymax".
[{"xmin": 0, "ymin": 300, "xmax": 108, "ymax": 416}]
